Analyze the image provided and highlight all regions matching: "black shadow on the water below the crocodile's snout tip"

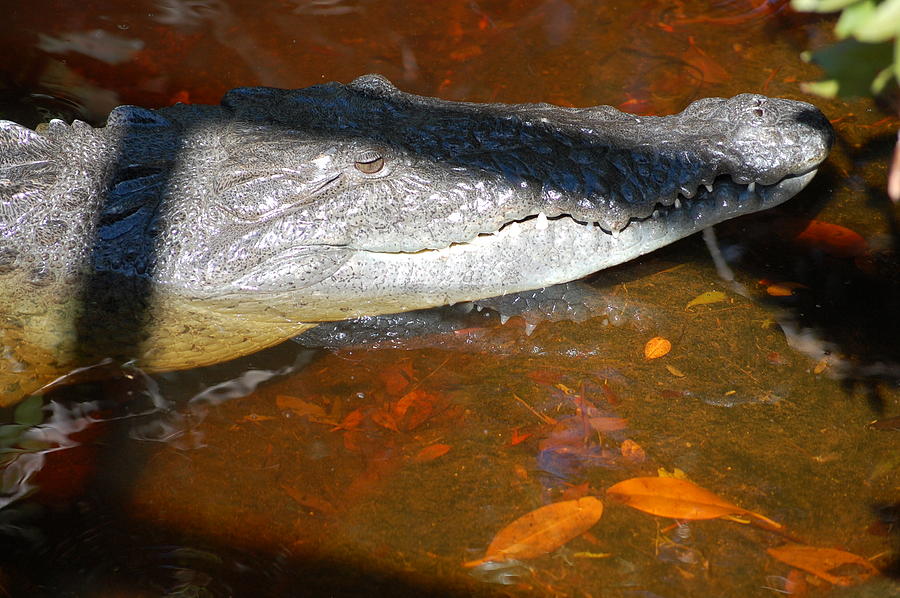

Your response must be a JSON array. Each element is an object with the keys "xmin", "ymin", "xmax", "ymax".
[{"xmin": 721, "ymin": 130, "xmax": 900, "ymax": 412}]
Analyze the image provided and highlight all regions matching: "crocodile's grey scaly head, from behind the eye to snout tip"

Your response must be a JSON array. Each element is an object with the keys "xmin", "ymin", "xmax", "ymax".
[{"xmin": 151, "ymin": 75, "xmax": 833, "ymax": 322}]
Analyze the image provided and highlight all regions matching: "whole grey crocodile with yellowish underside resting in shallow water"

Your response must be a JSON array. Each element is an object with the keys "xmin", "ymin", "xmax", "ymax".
[{"xmin": 0, "ymin": 75, "xmax": 833, "ymax": 404}]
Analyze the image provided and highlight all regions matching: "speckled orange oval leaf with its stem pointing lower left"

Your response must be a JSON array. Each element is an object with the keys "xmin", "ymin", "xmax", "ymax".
[{"xmin": 464, "ymin": 496, "xmax": 603, "ymax": 567}]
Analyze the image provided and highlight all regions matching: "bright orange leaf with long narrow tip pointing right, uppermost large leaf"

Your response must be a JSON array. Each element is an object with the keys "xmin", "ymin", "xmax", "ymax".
[{"xmin": 606, "ymin": 478, "xmax": 782, "ymax": 529}]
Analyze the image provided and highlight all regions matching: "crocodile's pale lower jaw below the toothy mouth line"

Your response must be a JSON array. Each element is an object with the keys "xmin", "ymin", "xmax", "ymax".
[{"xmin": 256, "ymin": 170, "xmax": 816, "ymax": 321}]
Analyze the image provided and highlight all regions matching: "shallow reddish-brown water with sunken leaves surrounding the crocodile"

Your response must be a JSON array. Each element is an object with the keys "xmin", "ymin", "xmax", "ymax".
[{"xmin": 0, "ymin": 0, "xmax": 900, "ymax": 597}]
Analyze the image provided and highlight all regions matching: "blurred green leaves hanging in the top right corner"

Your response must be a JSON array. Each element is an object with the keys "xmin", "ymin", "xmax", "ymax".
[{"xmin": 791, "ymin": 0, "xmax": 900, "ymax": 97}]
